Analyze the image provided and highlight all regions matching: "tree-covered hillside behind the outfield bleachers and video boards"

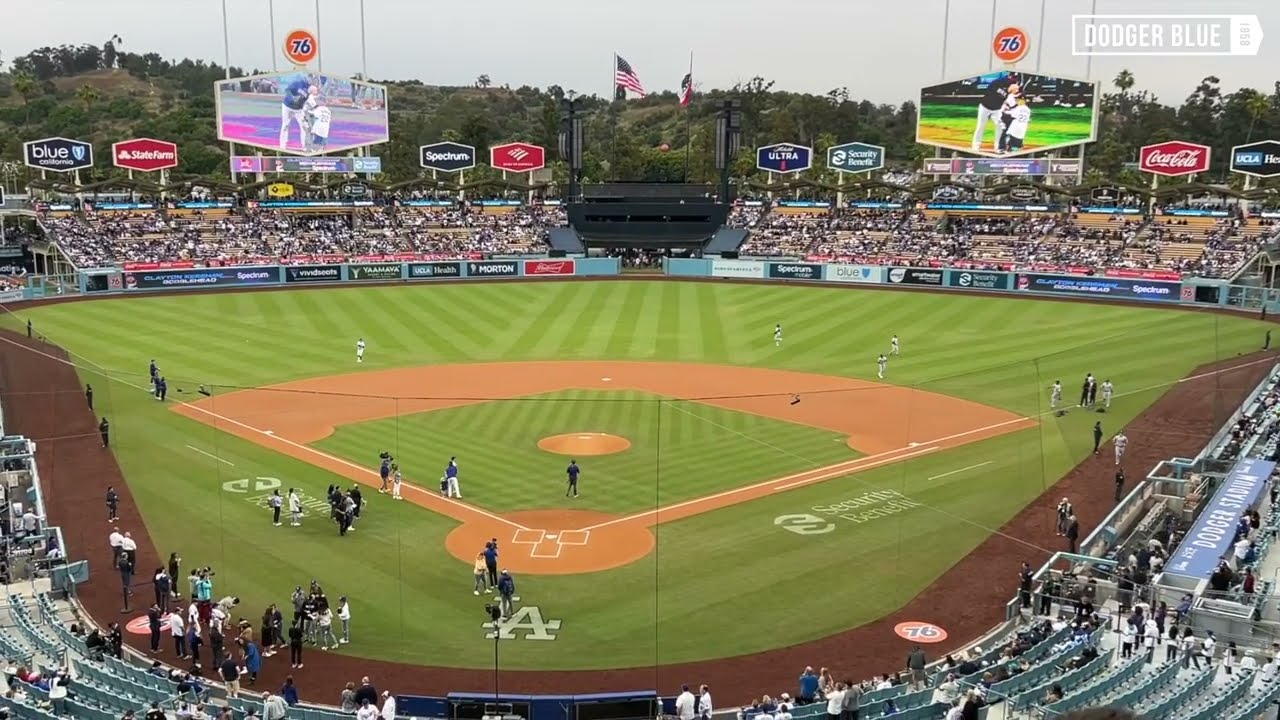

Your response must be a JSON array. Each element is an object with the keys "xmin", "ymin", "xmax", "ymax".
[{"xmin": 0, "ymin": 36, "xmax": 1280, "ymax": 182}]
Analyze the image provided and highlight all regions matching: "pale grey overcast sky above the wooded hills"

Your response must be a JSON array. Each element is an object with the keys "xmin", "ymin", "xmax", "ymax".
[{"xmin": 0, "ymin": 0, "xmax": 1280, "ymax": 108}]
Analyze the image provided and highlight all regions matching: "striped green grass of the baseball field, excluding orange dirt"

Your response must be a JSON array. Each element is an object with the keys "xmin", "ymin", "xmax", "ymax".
[{"xmin": 10, "ymin": 281, "xmax": 1265, "ymax": 669}]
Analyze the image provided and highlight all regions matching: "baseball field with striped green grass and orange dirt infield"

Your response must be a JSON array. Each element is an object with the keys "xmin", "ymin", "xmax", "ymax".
[{"xmin": 6, "ymin": 281, "xmax": 1266, "ymax": 678}]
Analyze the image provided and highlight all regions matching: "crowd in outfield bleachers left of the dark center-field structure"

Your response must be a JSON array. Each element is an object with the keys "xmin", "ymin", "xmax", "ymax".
[{"xmin": 42, "ymin": 205, "xmax": 564, "ymax": 268}]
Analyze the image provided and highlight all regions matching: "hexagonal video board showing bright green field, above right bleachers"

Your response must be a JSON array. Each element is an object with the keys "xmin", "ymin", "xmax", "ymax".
[{"xmin": 915, "ymin": 70, "xmax": 1100, "ymax": 158}]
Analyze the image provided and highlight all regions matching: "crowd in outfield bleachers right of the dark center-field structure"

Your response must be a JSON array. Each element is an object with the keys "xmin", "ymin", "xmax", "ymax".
[{"xmin": 741, "ymin": 208, "xmax": 1275, "ymax": 277}]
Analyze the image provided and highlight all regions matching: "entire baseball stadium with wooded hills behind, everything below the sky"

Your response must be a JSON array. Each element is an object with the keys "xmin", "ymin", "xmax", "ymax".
[{"xmin": 0, "ymin": 0, "xmax": 1280, "ymax": 720}]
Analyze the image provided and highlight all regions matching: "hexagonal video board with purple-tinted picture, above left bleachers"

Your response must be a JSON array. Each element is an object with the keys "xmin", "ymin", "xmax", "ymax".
[{"xmin": 214, "ymin": 69, "xmax": 390, "ymax": 155}]
